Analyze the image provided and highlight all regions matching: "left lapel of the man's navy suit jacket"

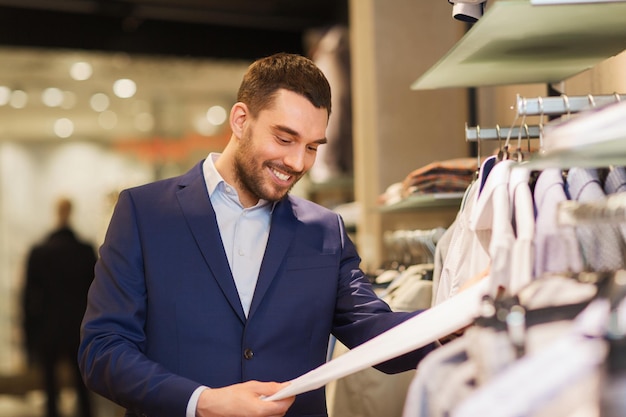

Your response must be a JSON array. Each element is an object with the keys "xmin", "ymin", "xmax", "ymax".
[{"xmin": 177, "ymin": 163, "xmax": 245, "ymax": 322}]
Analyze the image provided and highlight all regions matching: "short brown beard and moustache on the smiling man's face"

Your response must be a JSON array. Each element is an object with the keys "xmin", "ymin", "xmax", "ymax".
[{"xmin": 234, "ymin": 129, "xmax": 302, "ymax": 202}]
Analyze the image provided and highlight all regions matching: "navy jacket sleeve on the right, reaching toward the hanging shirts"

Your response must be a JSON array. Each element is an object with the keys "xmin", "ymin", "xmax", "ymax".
[{"xmin": 333, "ymin": 213, "xmax": 436, "ymax": 374}]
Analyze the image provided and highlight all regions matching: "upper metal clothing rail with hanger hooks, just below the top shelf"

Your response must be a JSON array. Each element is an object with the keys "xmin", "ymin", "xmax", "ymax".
[{"xmin": 512, "ymin": 93, "xmax": 626, "ymax": 116}]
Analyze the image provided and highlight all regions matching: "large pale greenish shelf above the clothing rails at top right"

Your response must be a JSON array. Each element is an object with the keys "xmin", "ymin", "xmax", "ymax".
[{"xmin": 411, "ymin": 0, "xmax": 626, "ymax": 90}]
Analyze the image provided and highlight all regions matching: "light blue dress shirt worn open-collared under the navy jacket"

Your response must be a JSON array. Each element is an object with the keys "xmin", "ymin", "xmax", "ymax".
[{"xmin": 187, "ymin": 152, "xmax": 274, "ymax": 417}]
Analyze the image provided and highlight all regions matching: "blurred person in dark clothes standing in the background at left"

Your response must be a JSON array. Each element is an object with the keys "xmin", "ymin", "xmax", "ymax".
[{"xmin": 22, "ymin": 198, "xmax": 96, "ymax": 417}]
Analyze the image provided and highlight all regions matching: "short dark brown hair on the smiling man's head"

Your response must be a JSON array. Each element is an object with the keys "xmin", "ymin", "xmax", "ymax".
[{"xmin": 237, "ymin": 52, "xmax": 331, "ymax": 116}]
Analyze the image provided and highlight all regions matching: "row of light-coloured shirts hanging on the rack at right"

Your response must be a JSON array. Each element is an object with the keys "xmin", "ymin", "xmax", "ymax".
[{"xmin": 402, "ymin": 96, "xmax": 626, "ymax": 417}]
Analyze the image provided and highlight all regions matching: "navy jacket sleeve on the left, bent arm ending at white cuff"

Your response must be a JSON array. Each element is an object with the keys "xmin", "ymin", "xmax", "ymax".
[{"xmin": 78, "ymin": 191, "xmax": 200, "ymax": 417}]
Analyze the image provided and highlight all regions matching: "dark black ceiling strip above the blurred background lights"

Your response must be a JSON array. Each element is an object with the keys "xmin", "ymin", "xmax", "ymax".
[{"xmin": 0, "ymin": 0, "xmax": 347, "ymax": 59}]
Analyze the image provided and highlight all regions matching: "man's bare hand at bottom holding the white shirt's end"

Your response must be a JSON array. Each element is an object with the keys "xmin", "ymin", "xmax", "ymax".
[{"xmin": 196, "ymin": 381, "xmax": 296, "ymax": 417}]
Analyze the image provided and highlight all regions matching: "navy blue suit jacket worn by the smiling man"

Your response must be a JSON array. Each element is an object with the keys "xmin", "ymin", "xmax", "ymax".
[{"xmin": 79, "ymin": 163, "xmax": 432, "ymax": 417}]
